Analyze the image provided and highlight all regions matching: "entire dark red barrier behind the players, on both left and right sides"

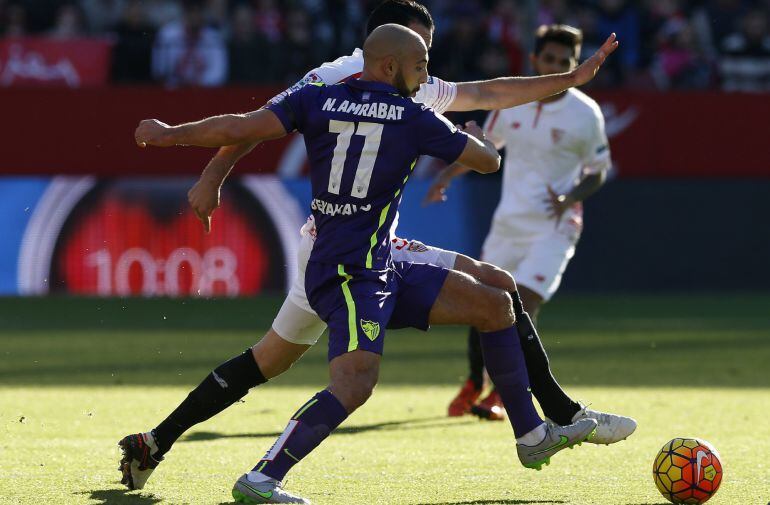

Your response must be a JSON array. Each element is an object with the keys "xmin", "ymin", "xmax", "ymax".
[{"xmin": 0, "ymin": 87, "xmax": 770, "ymax": 177}]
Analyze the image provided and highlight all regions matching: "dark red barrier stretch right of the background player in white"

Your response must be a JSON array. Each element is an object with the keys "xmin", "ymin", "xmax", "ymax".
[{"xmin": 596, "ymin": 92, "xmax": 770, "ymax": 177}]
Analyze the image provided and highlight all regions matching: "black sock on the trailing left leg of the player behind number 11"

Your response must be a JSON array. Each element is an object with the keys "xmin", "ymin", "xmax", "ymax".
[{"xmin": 152, "ymin": 349, "xmax": 267, "ymax": 458}]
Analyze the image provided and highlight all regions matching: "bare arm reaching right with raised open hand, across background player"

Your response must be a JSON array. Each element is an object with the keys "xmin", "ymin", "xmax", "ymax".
[{"xmin": 448, "ymin": 33, "xmax": 618, "ymax": 111}]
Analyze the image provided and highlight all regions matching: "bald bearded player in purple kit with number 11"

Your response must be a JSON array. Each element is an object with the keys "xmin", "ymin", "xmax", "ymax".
[{"xmin": 129, "ymin": 25, "xmax": 597, "ymax": 503}]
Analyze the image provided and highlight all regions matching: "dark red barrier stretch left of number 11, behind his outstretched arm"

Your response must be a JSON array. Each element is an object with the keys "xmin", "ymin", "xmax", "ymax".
[{"xmin": 0, "ymin": 87, "xmax": 286, "ymax": 176}]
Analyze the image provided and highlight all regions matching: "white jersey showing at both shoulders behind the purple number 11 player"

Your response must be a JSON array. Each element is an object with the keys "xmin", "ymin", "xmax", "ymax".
[{"xmin": 270, "ymin": 48, "xmax": 457, "ymax": 114}]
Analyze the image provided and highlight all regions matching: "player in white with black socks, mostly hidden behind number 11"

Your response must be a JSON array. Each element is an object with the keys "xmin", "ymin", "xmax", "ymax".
[{"xmin": 182, "ymin": 0, "xmax": 633, "ymax": 434}]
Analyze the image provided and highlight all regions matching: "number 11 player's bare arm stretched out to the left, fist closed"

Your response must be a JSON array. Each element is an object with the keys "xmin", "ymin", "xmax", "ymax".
[{"xmin": 134, "ymin": 109, "xmax": 287, "ymax": 147}]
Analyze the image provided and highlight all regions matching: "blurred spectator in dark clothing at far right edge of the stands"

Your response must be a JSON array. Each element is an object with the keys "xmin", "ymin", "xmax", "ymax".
[{"xmin": 720, "ymin": 9, "xmax": 770, "ymax": 92}]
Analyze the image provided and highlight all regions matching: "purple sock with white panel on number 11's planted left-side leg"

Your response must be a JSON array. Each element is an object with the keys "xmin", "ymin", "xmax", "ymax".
[{"xmin": 254, "ymin": 390, "xmax": 348, "ymax": 480}]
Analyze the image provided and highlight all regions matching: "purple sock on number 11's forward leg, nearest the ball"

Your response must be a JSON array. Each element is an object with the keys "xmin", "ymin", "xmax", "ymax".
[{"xmin": 480, "ymin": 326, "xmax": 543, "ymax": 438}]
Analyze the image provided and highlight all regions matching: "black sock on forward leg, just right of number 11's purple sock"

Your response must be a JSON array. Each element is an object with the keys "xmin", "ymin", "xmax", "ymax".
[{"xmin": 514, "ymin": 310, "xmax": 580, "ymax": 426}]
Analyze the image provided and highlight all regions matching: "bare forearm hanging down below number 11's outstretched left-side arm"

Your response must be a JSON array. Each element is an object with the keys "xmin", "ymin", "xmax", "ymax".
[{"xmin": 187, "ymin": 142, "xmax": 257, "ymax": 233}]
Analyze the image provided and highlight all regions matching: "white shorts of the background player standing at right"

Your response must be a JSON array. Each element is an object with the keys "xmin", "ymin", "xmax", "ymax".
[{"xmin": 481, "ymin": 218, "xmax": 582, "ymax": 302}]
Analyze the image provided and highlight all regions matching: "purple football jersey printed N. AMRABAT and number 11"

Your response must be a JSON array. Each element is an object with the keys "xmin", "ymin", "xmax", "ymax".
[{"xmin": 268, "ymin": 79, "xmax": 468, "ymax": 270}]
